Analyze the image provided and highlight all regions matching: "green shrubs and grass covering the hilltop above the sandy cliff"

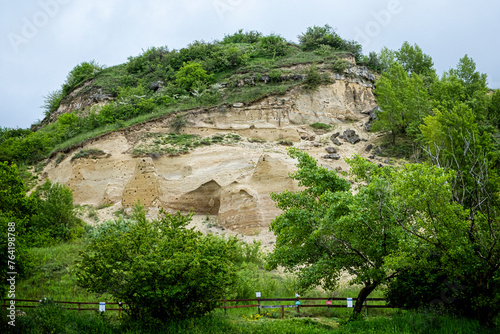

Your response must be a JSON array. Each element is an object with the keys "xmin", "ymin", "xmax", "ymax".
[{"xmin": 0, "ymin": 25, "xmax": 370, "ymax": 164}]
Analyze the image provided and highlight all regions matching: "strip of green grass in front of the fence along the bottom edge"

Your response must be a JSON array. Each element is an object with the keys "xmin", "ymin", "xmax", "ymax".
[{"xmin": 0, "ymin": 305, "xmax": 498, "ymax": 334}]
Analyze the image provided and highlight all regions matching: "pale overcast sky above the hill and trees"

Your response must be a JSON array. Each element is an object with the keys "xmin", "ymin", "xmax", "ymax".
[{"xmin": 0, "ymin": 0, "xmax": 500, "ymax": 128}]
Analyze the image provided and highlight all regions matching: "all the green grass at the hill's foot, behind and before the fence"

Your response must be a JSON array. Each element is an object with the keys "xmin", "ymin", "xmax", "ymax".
[{"xmin": 9, "ymin": 239, "xmax": 498, "ymax": 334}]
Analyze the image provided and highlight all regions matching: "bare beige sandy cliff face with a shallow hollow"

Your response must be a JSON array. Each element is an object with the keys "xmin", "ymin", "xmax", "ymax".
[{"xmin": 44, "ymin": 68, "xmax": 375, "ymax": 235}]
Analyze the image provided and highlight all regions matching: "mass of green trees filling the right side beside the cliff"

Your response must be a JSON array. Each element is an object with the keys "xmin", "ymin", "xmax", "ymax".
[{"xmin": 269, "ymin": 42, "xmax": 500, "ymax": 326}]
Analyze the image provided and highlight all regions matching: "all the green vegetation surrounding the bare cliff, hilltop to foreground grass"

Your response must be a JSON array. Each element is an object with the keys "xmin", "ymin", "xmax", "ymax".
[{"xmin": 0, "ymin": 25, "xmax": 500, "ymax": 333}]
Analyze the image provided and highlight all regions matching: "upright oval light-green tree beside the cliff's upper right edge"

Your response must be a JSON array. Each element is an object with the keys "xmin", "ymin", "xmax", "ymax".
[{"xmin": 372, "ymin": 62, "xmax": 430, "ymax": 144}]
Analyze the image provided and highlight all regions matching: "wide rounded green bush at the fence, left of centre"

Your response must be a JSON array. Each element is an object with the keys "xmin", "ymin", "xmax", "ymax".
[{"xmin": 77, "ymin": 204, "xmax": 237, "ymax": 320}]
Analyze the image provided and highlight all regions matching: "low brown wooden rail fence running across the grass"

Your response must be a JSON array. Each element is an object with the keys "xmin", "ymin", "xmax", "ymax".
[{"xmin": 2, "ymin": 297, "xmax": 392, "ymax": 317}]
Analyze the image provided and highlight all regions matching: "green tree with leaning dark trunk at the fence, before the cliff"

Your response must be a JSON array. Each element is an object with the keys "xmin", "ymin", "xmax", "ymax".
[{"xmin": 268, "ymin": 149, "xmax": 398, "ymax": 317}]
